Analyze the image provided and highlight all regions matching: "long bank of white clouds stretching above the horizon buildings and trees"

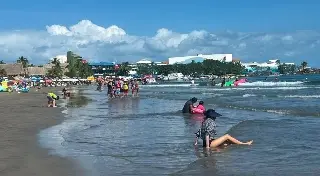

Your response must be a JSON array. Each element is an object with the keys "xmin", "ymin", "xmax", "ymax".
[{"xmin": 0, "ymin": 20, "xmax": 320, "ymax": 64}]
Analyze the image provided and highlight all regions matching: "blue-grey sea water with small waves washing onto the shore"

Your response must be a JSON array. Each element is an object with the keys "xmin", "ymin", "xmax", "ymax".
[{"xmin": 39, "ymin": 75, "xmax": 320, "ymax": 176}]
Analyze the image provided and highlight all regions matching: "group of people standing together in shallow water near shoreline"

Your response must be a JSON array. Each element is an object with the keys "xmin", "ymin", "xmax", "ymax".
[{"xmin": 97, "ymin": 78, "xmax": 139, "ymax": 98}]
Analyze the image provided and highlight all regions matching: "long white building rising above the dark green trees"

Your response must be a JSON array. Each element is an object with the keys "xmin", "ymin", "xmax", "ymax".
[{"xmin": 168, "ymin": 54, "xmax": 232, "ymax": 65}]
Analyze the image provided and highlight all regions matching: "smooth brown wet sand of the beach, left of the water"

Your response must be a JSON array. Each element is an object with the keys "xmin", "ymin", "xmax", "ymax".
[{"xmin": 0, "ymin": 88, "xmax": 84, "ymax": 176}]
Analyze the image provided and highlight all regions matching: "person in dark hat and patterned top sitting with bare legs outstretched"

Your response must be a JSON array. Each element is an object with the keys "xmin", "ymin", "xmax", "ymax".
[{"xmin": 195, "ymin": 109, "xmax": 253, "ymax": 148}]
